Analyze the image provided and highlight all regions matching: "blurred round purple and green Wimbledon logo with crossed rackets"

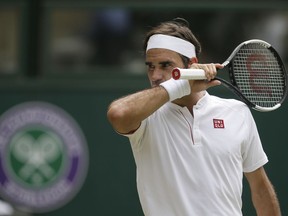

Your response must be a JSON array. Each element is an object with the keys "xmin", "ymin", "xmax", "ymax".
[{"xmin": 0, "ymin": 102, "xmax": 88, "ymax": 213}]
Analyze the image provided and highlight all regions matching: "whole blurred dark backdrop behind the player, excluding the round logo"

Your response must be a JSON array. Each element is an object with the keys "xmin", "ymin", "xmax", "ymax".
[{"xmin": 0, "ymin": 0, "xmax": 288, "ymax": 216}]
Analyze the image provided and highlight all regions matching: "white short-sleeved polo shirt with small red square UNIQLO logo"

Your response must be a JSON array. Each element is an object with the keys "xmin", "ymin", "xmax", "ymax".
[{"xmin": 127, "ymin": 93, "xmax": 268, "ymax": 216}]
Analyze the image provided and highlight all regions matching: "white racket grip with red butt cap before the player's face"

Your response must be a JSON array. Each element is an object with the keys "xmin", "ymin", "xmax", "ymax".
[{"xmin": 172, "ymin": 68, "xmax": 207, "ymax": 80}]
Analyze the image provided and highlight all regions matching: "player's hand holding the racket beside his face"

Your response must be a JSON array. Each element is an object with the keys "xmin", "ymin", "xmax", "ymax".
[{"xmin": 189, "ymin": 63, "xmax": 224, "ymax": 93}]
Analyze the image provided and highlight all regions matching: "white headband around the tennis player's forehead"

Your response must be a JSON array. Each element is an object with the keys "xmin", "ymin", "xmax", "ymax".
[{"xmin": 146, "ymin": 34, "xmax": 196, "ymax": 58}]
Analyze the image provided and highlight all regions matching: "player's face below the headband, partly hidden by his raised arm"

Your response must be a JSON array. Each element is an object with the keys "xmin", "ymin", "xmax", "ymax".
[{"xmin": 145, "ymin": 48, "xmax": 184, "ymax": 87}]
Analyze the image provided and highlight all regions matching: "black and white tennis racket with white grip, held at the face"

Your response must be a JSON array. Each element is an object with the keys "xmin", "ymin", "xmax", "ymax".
[{"xmin": 172, "ymin": 39, "xmax": 287, "ymax": 112}]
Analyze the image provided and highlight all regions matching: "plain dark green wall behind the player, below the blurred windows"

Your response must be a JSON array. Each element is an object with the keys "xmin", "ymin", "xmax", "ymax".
[{"xmin": 0, "ymin": 81, "xmax": 288, "ymax": 216}]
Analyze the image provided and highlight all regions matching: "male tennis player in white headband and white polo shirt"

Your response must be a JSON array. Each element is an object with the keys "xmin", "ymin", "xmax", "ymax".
[{"xmin": 107, "ymin": 18, "xmax": 281, "ymax": 216}]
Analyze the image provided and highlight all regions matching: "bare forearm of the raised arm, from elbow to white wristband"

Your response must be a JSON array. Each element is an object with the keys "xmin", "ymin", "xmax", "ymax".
[{"xmin": 107, "ymin": 87, "xmax": 169, "ymax": 133}]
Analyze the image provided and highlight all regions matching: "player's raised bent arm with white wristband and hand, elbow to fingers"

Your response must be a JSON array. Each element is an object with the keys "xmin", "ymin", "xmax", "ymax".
[{"xmin": 107, "ymin": 61, "xmax": 222, "ymax": 134}]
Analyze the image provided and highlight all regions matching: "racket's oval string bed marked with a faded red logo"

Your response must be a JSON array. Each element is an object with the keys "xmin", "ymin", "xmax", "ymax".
[{"xmin": 233, "ymin": 44, "xmax": 286, "ymax": 107}]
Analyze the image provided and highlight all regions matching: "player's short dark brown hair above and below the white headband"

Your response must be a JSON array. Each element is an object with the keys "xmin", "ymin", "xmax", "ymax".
[{"xmin": 143, "ymin": 18, "xmax": 201, "ymax": 67}]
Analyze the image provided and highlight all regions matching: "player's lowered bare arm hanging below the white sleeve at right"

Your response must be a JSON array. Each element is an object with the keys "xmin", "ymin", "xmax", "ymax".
[{"xmin": 245, "ymin": 167, "xmax": 281, "ymax": 216}]
